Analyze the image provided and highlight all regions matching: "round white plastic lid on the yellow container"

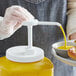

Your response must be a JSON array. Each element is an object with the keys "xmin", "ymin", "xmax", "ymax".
[{"xmin": 6, "ymin": 46, "xmax": 44, "ymax": 63}]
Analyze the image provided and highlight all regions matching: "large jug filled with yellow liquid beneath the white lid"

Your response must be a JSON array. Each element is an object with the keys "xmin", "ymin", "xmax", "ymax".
[{"xmin": 0, "ymin": 56, "xmax": 54, "ymax": 76}]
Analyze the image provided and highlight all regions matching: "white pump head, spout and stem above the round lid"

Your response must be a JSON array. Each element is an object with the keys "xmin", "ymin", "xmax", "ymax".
[{"xmin": 23, "ymin": 19, "xmax": 61, "ymax": 48}]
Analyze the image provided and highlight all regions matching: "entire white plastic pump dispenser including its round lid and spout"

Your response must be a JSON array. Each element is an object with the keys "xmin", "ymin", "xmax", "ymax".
[{"xmin": 6, "ymin": 19, "xmax": 61, "ymax": 63}]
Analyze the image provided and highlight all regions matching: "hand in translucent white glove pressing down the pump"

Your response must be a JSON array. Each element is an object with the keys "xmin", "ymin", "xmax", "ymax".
[{"xmin": 0, "ymin": 5, "xmax": 34, "ymax": 40}]
